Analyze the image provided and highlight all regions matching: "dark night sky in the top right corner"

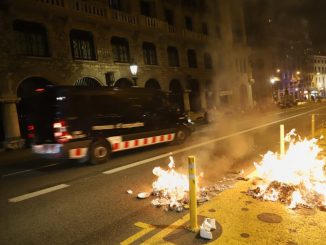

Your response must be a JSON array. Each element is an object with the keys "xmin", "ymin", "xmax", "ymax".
[{"xmin": 245, "ymin": 0, "xmax": 326, "ymax": 54}]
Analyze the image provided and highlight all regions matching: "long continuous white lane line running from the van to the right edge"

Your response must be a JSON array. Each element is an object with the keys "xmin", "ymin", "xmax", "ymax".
[{"xmin": 102, "ymin": 106, "xmax": 326, "ymax": 174}]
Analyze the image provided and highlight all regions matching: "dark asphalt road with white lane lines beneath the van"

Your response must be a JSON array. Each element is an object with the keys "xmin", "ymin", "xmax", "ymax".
[{"xmin": 0, "ymin": 103, "xmax": 326, "ymax": 244}]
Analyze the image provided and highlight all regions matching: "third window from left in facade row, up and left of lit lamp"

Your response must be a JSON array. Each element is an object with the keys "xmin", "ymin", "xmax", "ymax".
[{"xmin": 111, "ymin": 37, "xmax": 130, "ymax": 63}]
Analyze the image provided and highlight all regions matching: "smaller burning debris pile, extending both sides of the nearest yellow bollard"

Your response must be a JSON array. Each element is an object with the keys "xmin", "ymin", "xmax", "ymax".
[{"xmin": 152, "ymin": 156, "xmax": 236, "ymax": 212}]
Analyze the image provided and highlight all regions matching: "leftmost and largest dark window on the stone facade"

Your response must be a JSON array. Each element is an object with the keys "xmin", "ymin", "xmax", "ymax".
[{"xmin": 13, "ymin": 20, "xmax": 49, "ymax": 57}]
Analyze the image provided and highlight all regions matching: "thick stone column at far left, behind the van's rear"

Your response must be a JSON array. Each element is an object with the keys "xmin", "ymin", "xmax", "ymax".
[{"xmin": 2, "ymin": 99, "xmax": 25, "ymax": 149}]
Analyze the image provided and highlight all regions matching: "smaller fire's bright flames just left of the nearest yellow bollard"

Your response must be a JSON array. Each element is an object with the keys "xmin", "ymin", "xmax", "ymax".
[{"xmin": 152, "ymin": 156, "xmax": 189, "ymax": 208}]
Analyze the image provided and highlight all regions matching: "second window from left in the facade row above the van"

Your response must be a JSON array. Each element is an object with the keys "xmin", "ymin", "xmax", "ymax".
[{"xmin": 70, "ymin": 30, "xmax": 96, "ymax": 60}]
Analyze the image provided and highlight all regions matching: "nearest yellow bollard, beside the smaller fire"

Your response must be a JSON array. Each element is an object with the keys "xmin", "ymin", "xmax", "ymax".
[{"xmin": 188, "ymin": 156, "xmax": 198, "ymax": 232}]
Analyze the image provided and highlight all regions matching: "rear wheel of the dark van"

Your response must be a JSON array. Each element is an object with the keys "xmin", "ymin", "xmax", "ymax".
[{"xmin": 90, "ymin": 140, "xmax": 111, "ymax": 165}]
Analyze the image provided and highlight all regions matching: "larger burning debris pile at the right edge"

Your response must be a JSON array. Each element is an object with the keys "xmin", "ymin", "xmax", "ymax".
[{"xmin": 248, "ymin": 130, "xmax": 326, "ymax": 210}]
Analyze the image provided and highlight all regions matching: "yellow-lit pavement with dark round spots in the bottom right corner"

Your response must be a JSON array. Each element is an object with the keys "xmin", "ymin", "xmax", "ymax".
[{"xmin": 136, "ymin": 171, "xmax": 326, "ymax": 245}]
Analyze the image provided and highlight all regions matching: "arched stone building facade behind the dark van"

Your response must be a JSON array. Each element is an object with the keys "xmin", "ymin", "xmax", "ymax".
[{"xmin": 0, "ymin": 0, "xmax": 252, "ymax": 148}]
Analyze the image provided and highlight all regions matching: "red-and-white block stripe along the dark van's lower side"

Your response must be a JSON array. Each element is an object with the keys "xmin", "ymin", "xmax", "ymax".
[{"xmin": 69, "ymin": 133, "xmax": 175, "ymax": 159}]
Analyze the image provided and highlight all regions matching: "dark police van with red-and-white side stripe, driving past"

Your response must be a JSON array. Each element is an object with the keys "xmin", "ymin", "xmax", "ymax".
[{"xmin": 25, "ymin": 86, "xmax": 193, "ymax": 164}]
